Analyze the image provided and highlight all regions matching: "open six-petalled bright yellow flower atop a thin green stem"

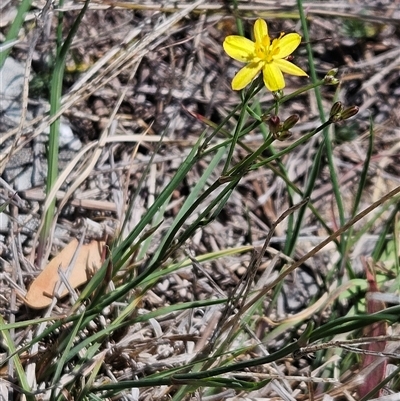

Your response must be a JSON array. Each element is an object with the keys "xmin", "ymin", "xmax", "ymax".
[{"xmin": 223, "ymin": 19, "xmax": 307, "ymax": 92}]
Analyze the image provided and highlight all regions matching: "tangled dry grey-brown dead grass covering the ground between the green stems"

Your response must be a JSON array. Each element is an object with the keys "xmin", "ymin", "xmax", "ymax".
[{"xmin": 0, "ymin": 0, "xmax": 400, "ymax": 400}]
